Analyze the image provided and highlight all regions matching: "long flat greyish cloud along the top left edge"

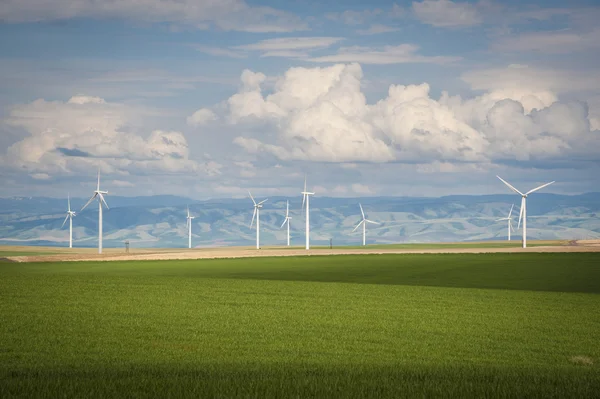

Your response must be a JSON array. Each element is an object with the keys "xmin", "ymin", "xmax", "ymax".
[{"xmin": 0, "ymin": 0, "xmax": 307, "ymax": 32}]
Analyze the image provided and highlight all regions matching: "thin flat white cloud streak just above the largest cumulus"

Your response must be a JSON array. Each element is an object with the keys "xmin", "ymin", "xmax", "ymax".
[{"xmin": 308, "ymin": 44, "xmax": 461, "ymax": 65}]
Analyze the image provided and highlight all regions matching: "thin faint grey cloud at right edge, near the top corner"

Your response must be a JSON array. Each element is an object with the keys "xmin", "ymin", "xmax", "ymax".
[{"xmin": 491, "ymin": 29, "xmax": 600, "ymax": 54}]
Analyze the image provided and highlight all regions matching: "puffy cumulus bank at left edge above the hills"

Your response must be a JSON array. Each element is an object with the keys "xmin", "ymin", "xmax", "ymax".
[{"xmin": 0, "ymin": 96, "xmax": 220, "ymax": 176}]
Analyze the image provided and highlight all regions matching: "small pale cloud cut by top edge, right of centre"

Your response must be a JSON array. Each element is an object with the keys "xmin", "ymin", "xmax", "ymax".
[{"xmin": 412, "ymin": 0, "xmax": 483, "ymax": 28}]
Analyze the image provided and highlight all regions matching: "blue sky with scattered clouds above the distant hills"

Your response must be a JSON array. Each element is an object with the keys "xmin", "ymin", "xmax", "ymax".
[{"xmin": 0, "ymin": 0, "xmax": 600, "ymax": 200}]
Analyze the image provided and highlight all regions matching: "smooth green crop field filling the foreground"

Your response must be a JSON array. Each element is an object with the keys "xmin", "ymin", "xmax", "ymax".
[{"xmin": 0, "ymin": 253, "xmax": 600, "ymax": 398}]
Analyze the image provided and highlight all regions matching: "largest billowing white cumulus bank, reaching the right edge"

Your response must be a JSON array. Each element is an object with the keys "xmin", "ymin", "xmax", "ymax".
[{"xmin": 192, "ymin": 64, "xmax": 600, "ymax": 167}]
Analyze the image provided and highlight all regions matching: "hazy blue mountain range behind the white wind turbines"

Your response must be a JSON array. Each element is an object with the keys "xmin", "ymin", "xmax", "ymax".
[{"xmin": 0, "ymin": 193, "xmax": 600, "ymax": 248}]
